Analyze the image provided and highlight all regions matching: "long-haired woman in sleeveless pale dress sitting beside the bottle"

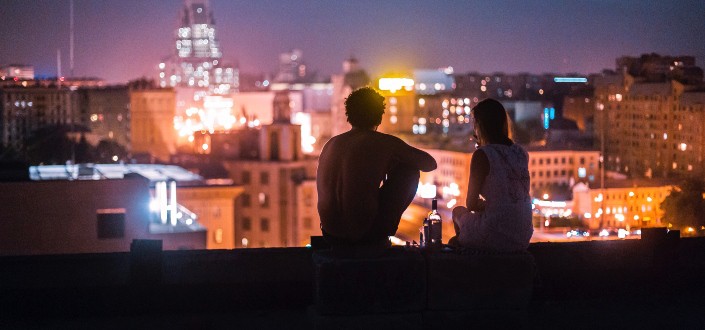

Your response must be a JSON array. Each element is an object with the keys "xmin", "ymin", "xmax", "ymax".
[{"xmin": 451, "ymin": 99, "xmax": 534, "ymax": 252}]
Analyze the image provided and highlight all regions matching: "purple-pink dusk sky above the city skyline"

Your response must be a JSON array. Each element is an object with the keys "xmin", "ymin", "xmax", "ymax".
[{"xmin": 0, "ymin": 0, "xmax": 705, "ymax": 83}]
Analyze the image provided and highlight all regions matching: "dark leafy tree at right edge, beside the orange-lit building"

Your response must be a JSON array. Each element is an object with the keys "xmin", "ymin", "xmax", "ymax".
[{"xmin": 660, "ymin": 178, "xmax": 705, "ymax": 228}]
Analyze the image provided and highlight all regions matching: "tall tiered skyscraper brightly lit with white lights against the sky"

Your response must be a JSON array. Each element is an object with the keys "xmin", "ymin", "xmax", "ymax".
[{"xmin": 159, "ymin": 0, "xmax": 238, "ymax": 100}]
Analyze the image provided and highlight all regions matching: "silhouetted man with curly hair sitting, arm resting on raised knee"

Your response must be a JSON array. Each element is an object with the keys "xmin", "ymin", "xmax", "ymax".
[{"xmin": 316, "ymin": 87, "xmax": 436, "ymax": 249}]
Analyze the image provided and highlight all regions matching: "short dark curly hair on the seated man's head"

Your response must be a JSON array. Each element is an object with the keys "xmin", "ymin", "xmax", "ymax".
[{"xmin": 345, "ymin": 87, "xmax": 385, "ymax": 129}]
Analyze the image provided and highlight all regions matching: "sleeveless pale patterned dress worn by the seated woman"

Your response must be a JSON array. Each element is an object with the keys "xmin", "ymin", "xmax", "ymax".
[{"xmin": 457, "ymin": 144, "xmax": 534, "ymax": 252}]
